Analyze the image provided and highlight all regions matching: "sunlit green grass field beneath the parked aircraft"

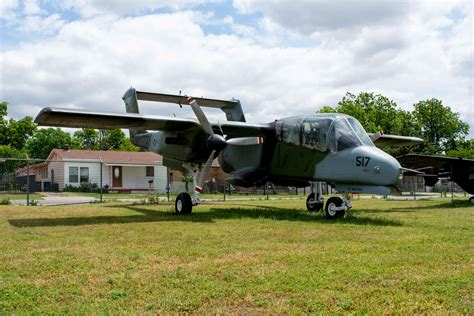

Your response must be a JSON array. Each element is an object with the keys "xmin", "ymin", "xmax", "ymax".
[{"xmin": 0, "ymin": 199, "xmax": 474, "ymax": 314}]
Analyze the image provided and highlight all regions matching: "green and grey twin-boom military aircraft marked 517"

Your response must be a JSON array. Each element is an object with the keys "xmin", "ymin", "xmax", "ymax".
[{"xmin": 35, "ymin": 88, "xmax": 422, "ymax": 218}]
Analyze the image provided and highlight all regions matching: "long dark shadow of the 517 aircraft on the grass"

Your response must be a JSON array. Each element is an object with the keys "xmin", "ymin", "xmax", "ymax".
[{"xmin": 8, "ymin": 205, "xmax": 402, "ymax": 227}]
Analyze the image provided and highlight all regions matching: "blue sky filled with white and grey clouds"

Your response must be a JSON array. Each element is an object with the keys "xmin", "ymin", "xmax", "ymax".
[{"xmin": 0, "ymin": 0, "xmax": 474, "ymax": 138}]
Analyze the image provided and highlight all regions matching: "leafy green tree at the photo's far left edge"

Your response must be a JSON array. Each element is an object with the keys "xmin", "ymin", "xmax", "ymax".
[{"xmin": 0, "ymin": 102, "xmax": 36, "ymax": 150}]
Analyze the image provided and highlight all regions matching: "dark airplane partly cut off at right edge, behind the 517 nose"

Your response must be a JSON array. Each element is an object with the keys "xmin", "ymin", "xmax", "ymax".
[{"xmin": 397, "ymin": 154, "xmax": 474, "ymax": 203}]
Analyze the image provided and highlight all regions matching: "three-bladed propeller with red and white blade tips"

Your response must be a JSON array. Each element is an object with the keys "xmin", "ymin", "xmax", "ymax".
[{"xmin": 186, "ymin": 97, "xmax": 263, "ymax": 193}]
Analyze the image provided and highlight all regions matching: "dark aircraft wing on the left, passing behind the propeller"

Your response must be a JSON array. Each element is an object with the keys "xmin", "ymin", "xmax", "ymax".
[{"xmin": 35, "ymin": 107, "xmax": 269, "ymax": 138}]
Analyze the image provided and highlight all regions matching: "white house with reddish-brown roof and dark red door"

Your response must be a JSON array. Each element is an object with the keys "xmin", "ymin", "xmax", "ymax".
[{"xmin": 16, "ymin": 148, "xmax": 224, "ymax": 193}]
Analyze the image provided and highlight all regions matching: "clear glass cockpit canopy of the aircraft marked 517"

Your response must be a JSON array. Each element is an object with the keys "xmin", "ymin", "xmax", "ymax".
[{"xmin": 276, "ymin": 114, "xmax": 374, "ymax": 152}]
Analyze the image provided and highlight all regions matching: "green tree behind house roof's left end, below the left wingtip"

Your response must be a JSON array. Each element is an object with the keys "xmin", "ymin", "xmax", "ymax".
[{"xmin": 26, "ymin": 128, "xmax": 80, "ymax": 159}]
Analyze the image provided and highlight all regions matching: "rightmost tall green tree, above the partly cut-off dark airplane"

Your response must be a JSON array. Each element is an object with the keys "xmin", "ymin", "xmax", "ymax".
[{"xmin": 413, "ymin": 99, "xmax": 469, "ymax": 154}]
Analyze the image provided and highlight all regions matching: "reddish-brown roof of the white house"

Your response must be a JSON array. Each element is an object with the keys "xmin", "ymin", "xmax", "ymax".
[{"xmin": 48, "ymin": 149, "xmax": 163, "ymax": 165}]
